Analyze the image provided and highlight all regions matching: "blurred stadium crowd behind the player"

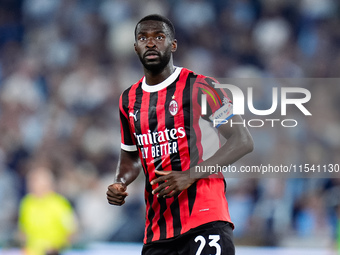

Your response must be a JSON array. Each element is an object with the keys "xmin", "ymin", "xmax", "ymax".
[{"xmin": 0, "ymin": 0, "xmax": 340, "ymax": 251}]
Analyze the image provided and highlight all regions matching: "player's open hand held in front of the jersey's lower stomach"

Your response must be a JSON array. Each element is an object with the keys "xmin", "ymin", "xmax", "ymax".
[{"xmin": 151, "ymin": 170, "xmax": 196, "ymax": 198}]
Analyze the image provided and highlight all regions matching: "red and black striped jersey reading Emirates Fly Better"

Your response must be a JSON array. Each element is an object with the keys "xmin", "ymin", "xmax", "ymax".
[{"xmin": 119, "ymin": 67, "xmax": 231, "ymax": 243}]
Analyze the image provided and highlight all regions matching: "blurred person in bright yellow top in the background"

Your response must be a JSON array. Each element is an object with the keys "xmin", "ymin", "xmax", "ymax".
[{"xmin": 19, "ymin": 167, "xmax": 77, "ymax": 255}]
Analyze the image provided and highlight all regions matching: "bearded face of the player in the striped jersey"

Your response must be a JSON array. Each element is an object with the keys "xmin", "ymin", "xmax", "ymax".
[{"xmin": 135, "ymin": 20, "xmax": 177, "ymax": 73}]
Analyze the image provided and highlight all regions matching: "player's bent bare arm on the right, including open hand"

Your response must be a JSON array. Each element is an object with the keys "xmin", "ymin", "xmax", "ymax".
[{"xmin": 151, "ymin": 115, "xmax": 254, "ymax": 198}]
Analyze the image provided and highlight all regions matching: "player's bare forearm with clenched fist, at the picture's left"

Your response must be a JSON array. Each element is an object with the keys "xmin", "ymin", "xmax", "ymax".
[{"xmin": 106, "ymin": 150, "xmax": 141, "ymax": 205}]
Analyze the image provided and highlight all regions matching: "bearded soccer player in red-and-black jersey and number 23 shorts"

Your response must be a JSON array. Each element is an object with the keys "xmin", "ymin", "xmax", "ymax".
[{"xmin": 107, "ymin": 15, "xmax": 253, "ymax": 255}]
